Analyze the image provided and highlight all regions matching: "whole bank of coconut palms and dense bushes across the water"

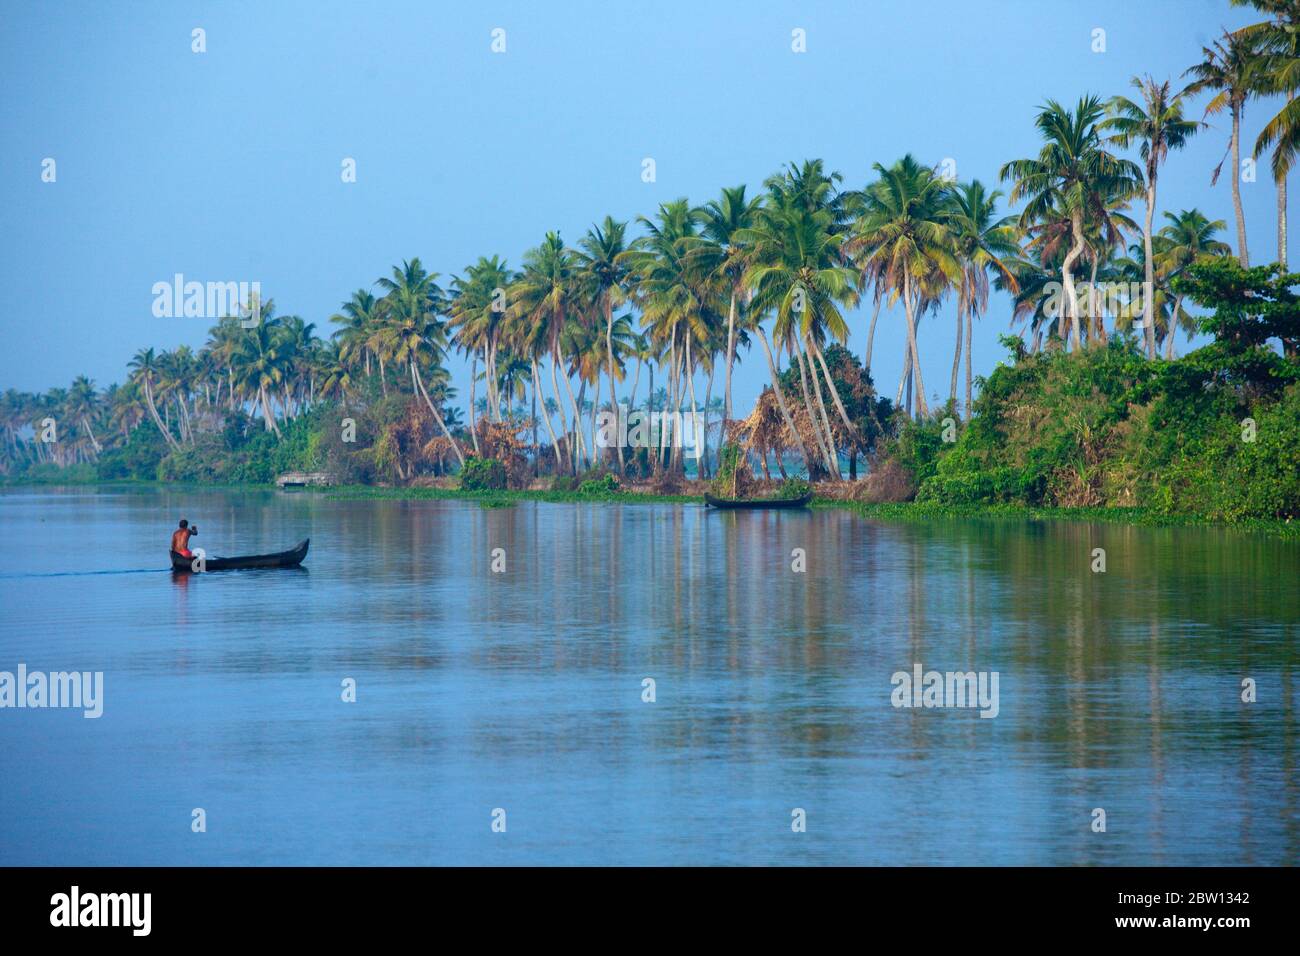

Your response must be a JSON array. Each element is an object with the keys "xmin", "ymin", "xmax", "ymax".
[{"xmin": 0, "ymin": 0, "xmax": 1300, "ymax": 519}]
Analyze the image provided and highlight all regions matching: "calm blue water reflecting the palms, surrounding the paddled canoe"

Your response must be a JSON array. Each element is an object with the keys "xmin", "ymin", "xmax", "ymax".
[{"xmin": 0, "ymin": 489, "xmax": 1300, "ymax": 865}]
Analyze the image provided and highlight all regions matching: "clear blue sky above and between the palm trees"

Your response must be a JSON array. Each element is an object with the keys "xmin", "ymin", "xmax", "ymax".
[{"xmin": 0, "ymin": 0, "xmax": 1275, "ymax": 408}]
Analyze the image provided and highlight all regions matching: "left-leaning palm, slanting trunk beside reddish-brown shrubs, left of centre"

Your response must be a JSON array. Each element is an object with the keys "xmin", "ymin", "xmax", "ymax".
[{"xmin": 376, "ymin": 258, "xmax": 465, "ymax": 466}]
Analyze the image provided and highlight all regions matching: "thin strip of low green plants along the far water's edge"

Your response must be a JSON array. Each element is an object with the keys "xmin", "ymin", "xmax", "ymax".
[{"xmin": 0, "ymin": 480, "xmax": 1300, "ymax": 540}]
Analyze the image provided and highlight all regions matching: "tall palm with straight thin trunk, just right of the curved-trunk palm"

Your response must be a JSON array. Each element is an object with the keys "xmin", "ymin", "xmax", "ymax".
[{"xmin": 1102, "ymin": 77, "xmax": 1201, "ymax": 359}]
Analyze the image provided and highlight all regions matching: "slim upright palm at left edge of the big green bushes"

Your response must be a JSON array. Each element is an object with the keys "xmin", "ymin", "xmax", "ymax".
[{"xmin": 949, "ymin": 179, "xmax": 1019, "ymax": 418}]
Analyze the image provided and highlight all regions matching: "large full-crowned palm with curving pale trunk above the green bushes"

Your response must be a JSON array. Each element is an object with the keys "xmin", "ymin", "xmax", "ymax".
[{"xmin": 1000, "ymin": 95, "xmax": 1141, "ymax": 349}]
